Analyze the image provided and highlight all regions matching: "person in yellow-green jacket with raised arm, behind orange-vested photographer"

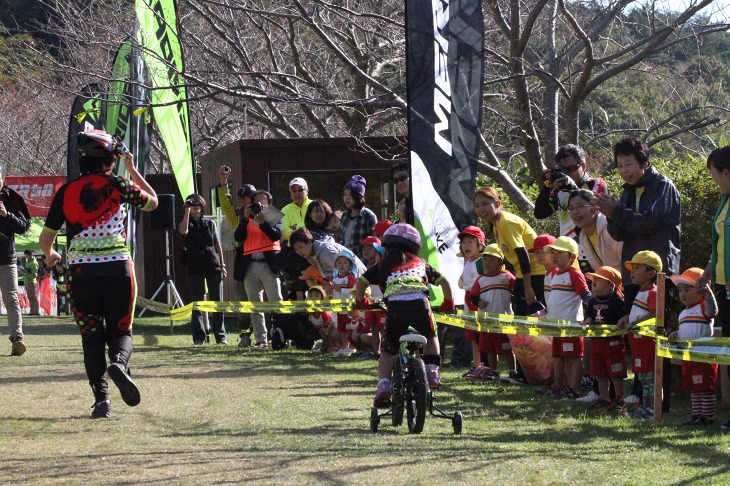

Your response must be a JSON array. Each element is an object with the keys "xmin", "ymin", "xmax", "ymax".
[{"xmin": 218, "ymin": 165, "xmax": 256, "ymax": 348}]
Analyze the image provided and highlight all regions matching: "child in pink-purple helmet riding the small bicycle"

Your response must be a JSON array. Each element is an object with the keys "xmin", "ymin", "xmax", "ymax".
[{"xmin": 355, "ymin": 223, "xmax": 454, "ymax": 407}]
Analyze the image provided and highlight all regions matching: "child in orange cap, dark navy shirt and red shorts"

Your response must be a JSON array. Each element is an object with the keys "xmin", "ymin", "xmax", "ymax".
[{"xmin": 583, "ymin": 266, "xmax": 626, "ymax": 414}]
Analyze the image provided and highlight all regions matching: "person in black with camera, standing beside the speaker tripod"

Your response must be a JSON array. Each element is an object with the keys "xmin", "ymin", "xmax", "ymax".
[{"xmin": 177, "ymin": 194, "xmax": 228, "ymax": 345}]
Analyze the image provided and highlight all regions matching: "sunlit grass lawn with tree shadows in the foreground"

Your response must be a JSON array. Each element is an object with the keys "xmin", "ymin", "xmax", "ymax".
[{"xmin": 0, "ymin": 317, "xmax": 730, "ymax": 485}]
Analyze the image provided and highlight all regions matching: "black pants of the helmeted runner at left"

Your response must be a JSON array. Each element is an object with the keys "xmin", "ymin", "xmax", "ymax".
[{"xmin": 68, "ymin": 261, "xmax": 137, "ymax": 401}]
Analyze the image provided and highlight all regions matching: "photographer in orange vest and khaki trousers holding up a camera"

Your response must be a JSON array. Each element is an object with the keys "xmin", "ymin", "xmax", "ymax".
[{"xmin": 233, "ymin": 190, "xmax": 283, "ymax": 348}]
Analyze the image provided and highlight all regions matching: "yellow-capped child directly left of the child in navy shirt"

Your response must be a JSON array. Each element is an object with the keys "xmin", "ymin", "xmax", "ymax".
[{"xmin": 546, "ymin": 236, "xmax": 591, "ymax": 398}]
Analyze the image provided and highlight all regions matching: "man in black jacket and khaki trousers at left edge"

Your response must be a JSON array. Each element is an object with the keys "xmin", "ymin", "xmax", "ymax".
[{"xmin": 0, "ymin": 172, "xmax": 30, "ymax": 356}]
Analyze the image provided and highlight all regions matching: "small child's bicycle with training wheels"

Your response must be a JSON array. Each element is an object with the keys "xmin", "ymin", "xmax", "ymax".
[{"xmin": 370, "ymin": 332, "xmax": 463, "ymax": 435}]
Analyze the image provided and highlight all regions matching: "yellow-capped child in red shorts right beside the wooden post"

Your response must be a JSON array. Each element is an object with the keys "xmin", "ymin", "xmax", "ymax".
[{"xmin": 618, "ymin": 250, "xmax": 662, "ymax": 419}]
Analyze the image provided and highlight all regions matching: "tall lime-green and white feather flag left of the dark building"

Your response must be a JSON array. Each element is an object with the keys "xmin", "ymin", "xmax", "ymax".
[{"xmin": 135, "ymin": 0, "xmax": 196, "ymax": 198}]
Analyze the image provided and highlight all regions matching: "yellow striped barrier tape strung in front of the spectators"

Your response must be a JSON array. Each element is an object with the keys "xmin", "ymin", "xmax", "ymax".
[{"xmin": 137, "ymin": 297, "xmax": 730, "ymax": 365}]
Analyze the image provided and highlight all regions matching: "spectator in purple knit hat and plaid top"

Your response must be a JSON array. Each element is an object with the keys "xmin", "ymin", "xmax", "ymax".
[{"xmin": 340, "ymin": 175, "xmax": 378, "ymax": 258}]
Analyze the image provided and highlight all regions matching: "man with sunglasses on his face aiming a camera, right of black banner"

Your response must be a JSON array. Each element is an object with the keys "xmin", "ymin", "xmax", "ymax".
[{"xmin": 534, "ymin": 144, "xmax": 608, "ymax": 238}]
